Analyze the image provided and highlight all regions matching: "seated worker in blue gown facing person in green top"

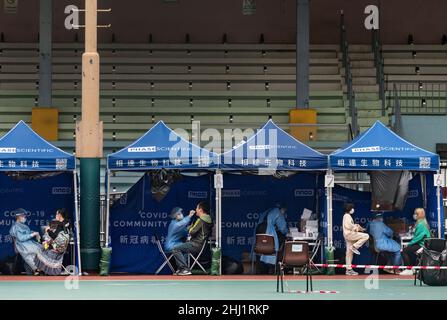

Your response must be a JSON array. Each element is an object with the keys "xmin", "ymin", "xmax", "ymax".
[{"xmin": 368, "ymin": 213, "xmax": 402, "ymax": 273}]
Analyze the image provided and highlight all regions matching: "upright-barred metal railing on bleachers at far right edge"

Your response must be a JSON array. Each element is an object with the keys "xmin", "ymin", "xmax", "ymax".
[{"xmin": 387, "ymin": 82, "xmax": 447, "ymax": 116}]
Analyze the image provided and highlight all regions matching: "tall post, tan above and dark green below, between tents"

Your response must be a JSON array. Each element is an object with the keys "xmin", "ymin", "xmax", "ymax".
[{"xmin": 76, "ymin": 0, "xmax": 103, "ymax": 270}]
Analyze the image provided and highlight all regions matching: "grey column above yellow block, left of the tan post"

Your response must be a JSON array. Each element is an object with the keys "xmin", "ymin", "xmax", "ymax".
[{"xmin": 39, "ymin": 0, "xmax": 53, "ymax": 107}]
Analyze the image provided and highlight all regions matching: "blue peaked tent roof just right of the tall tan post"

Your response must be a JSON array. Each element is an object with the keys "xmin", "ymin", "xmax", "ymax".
[{"xmin": 107, "ymin": 121, "xmax": 217, "ymax": 171}]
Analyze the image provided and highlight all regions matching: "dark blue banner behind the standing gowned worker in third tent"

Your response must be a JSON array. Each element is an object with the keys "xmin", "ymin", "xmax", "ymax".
[{"xmin": 222, "ymin": 173, "xmax": 324, "ymax": 261}]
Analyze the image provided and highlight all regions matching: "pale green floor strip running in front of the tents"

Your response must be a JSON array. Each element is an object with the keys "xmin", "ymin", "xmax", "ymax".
[{"xmin": 0, "ymin": 279, "xmax": 447, "ymax": 300}]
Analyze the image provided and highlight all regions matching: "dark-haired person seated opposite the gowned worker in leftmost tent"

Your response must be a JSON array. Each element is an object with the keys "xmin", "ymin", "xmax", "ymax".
[{"xmin": 35, "ymin": 209, "xmax": 70, "ymax": 276}]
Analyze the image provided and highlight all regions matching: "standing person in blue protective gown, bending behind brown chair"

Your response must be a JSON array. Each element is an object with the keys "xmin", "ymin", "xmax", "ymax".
[{"xmin": 258, "ymin": 203, "xmax": 289, "ymax": 273}]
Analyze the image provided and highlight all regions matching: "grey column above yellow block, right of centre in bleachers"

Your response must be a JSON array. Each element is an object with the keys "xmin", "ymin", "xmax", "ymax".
[{"xmin": 296, "ymin": 0, "xmax": 310, "ymax": 109}]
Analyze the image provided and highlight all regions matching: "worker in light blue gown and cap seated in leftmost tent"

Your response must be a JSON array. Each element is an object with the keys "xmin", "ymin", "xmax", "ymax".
[{"xmin": 9, "ymin": 208, "xmax": 41, "ymax": 275}]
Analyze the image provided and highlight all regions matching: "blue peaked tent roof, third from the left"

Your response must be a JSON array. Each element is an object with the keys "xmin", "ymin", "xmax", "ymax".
[{"xmin": 220, "ymin": 120, "xmax": 327, "ymax": 170}]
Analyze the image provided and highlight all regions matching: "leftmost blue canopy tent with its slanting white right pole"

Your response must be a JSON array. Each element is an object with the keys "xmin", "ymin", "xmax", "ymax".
[{"xmin": 0, "ymin": 121, "xmax": 81, "ymax": 274}]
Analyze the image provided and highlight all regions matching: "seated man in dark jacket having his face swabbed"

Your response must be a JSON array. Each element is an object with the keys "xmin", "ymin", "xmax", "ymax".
[{"xmin": 172, "ymin": 202, "xmax": 213, "ymax": 276}]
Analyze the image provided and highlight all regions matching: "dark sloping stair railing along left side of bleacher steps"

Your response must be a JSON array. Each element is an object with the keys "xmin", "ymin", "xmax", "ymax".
[{"xmin": 340, "ymin": 11, "xmax": 359, "ymax": 135}]
